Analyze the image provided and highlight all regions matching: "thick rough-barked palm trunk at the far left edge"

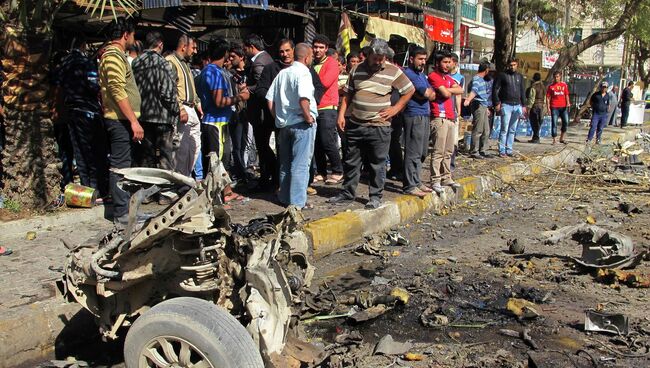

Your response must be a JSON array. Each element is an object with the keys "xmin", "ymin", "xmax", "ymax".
[{"xmin": 0, "ymin": 26, "xmax": 61, "ymax": 208}]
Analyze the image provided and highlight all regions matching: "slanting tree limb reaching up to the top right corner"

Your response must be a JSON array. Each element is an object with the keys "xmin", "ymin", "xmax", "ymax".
[{"xmin": 540, "ymin": 0, "xmax": 644, "ymax": 83}]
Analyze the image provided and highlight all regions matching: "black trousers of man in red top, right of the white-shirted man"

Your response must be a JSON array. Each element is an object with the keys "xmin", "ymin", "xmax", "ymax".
[{"xmin": 314, "ymin": 109, "xmax": 343, "ymax": 176}]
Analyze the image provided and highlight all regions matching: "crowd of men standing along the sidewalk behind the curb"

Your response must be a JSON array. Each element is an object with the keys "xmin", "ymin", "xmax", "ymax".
[{"xmin": 48, "ymin": 18, "xmax": 636, "ymax": 222}]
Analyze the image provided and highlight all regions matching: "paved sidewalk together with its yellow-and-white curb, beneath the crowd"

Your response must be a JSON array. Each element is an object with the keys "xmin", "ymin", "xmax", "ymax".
[{"xmin": 0, "ymin": 123, "xmax": 641, "ymax": 367}]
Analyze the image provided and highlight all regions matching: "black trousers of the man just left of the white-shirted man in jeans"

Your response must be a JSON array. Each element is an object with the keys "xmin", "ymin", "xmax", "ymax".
[{"xmin": 249, "ymin": 103, "xmax": 279, "ymax": 185}]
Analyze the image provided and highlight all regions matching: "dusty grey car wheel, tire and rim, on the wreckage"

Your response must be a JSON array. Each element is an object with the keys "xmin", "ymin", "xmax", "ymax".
[{"xmin": 124, "ymin": 297, "xmax": 264, "ymax": 368}]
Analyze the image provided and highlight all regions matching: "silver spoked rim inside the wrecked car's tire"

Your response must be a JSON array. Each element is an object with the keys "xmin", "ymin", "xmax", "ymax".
[{"xmin": 138, "ymin": 336, "xmax": 215, "ymax": 368}]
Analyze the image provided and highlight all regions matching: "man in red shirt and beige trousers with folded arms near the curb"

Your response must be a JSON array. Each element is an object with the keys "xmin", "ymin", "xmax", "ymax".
[{"xmin": 428, "ymin": 51, "xmax": 463, "ymax": 194}]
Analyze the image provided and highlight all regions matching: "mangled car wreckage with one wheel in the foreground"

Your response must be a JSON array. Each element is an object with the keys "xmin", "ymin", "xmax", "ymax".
[{"xmin": 63, "ymin": 155, "xmax": 313, "ymax": 367}]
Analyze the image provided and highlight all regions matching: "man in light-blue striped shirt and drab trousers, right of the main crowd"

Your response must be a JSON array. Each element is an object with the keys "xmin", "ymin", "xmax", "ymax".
[{"xmin": 464, "ymin": 63, "xmax": 492, "ymax": 160}]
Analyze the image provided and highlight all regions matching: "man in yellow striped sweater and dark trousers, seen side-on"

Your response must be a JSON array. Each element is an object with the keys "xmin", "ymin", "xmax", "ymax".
[{"xmin": 99, "ymin": 17, "xmax": 144, "ymax": 224}]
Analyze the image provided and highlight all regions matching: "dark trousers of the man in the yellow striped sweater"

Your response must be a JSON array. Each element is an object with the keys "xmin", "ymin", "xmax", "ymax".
[{"xmin": 104, "ymin": 119, "xmax": 133, "ymax": 218}]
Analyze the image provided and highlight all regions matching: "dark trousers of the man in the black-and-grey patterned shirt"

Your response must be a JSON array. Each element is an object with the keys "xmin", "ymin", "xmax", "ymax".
[{"xmin": 133, "ymin": 122, "xmax": 175, "ymax": 170}]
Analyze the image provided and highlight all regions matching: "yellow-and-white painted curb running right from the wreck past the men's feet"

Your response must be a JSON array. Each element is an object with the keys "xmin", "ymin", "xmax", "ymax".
[{"xmin": 304, "ymin": 128, "xmax": 641, "ymax": 258}]
